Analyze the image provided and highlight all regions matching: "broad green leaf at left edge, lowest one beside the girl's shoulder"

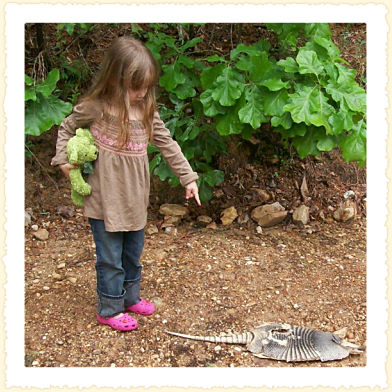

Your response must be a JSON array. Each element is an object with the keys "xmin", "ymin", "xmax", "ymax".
[{"xmin": 25, "ymin": 93, "xmax": 72, "ymax": 136}]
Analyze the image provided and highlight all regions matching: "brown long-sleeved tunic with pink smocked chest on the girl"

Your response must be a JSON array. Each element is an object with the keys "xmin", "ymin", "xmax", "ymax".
[{"xmin": 51, "ymin": 103, "xmax": 198, "ymax": 231}]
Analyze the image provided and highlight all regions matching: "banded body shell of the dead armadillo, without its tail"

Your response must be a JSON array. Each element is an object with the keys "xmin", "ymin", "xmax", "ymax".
[{"xmin": 262, "ymin": 326, "xmax": 349, "ymax": 362}]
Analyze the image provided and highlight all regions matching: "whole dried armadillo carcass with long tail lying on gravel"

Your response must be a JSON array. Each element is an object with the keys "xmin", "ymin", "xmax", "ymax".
[{"xmin": 165, "ymin": 323, "xmax": 364, "ymax": 362}]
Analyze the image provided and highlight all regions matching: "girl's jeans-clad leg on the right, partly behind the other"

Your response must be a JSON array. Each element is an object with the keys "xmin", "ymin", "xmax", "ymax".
[{"xmin": 122, "ymin": 229, "xmax": 144, "ymax": 308}]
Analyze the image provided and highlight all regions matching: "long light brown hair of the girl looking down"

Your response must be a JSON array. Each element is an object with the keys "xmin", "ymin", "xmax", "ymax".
[{"xmin": 83, "ymin": 37, "xmax": 159, "ymax": 146}]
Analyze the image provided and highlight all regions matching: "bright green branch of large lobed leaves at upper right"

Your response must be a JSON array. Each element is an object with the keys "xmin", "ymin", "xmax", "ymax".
[{"xmin": 200, "ymin": 24, "xmax": 366, "ymax": 165}]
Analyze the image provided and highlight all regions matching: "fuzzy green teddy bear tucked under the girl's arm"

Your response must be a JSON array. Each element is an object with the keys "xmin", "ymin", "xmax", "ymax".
[{"xmin": 67, "ymin": 128, "xmax": 98, "ymax": 207}]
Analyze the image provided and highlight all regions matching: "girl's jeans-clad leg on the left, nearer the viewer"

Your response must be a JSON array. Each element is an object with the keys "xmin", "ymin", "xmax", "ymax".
[{"xmin": 89, "ymin": 218, "xmax": 125, "ymax": 317}]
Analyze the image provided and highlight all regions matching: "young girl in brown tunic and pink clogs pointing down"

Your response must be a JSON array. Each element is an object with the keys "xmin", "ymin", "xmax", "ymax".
[{"xmin": 52, "ymin": 37, "xmax": 200, "ymax": 331}]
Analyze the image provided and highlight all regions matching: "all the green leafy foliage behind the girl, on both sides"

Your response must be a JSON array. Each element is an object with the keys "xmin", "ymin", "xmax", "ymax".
[{"xmin": 25, "ymin": 23, "xmax": 366, "ymax": 202}]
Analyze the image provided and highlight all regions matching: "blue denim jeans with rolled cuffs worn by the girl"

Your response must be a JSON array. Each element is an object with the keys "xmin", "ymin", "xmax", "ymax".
[{"xmin": 89, "ymin": 218, "xmax": 144, "ymax": 317}]
